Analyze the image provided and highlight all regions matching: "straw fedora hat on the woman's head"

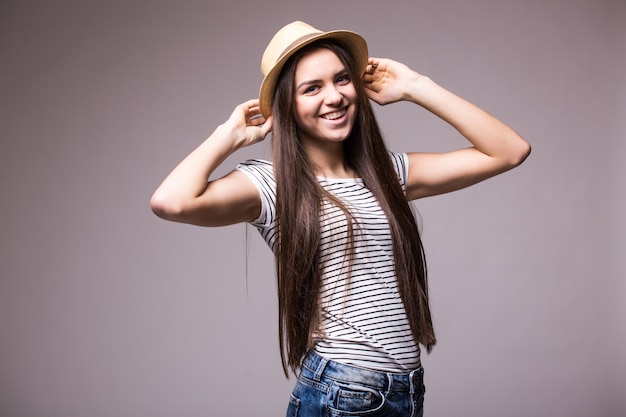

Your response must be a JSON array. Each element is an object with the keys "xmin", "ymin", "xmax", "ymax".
[{"xmin": 259, "ymin": 21, "xmax": 368, "ymax": 117}]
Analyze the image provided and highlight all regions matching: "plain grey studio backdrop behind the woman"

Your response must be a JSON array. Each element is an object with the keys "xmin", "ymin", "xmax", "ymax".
[{"xmin": 0, "ymin": 0, "xmax": 626, "ymax": 417}]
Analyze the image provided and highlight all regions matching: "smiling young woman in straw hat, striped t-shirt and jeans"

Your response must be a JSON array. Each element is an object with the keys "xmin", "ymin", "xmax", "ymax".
[{"xmin": 151, "ymin": 22, "xmax": 530, "ymax": 417}]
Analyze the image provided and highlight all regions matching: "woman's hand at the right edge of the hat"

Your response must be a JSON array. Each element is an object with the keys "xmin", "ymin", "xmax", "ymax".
[{"xmin": 363, "ymin": 57, "xmax": 420, "ymax": 105}]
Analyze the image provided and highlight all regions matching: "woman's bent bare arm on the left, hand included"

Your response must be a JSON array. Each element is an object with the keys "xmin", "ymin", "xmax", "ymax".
[{"xmin": 150, "ymin": 100, "xmax": 272, "ymax": 226}]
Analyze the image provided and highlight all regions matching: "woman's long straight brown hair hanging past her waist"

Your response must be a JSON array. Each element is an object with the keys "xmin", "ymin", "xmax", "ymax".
[{"xmin": 272, "ymin": 40, "xmax": 436, "ymax": 375}]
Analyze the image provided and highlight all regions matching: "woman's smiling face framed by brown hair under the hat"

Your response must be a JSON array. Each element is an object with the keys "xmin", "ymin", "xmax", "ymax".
[{"xmin": 294, "ymin": 48, "xmax": 357, "ymax": 146}]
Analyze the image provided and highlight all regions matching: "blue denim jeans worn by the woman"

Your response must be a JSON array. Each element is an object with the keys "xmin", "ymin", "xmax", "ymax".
[{"xmin": 287, "ymin": 352, "xmax": 425, "ymax": 417}]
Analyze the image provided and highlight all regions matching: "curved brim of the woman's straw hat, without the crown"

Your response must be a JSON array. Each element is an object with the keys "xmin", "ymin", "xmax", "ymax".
[{"xmin": 259, "ymin": 30, "xmax": 368, "ymax": 117}]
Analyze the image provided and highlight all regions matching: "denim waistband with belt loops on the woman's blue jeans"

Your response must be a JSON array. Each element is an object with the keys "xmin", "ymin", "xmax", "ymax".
[{"xmin": 300, "ymin": 351, "xmax": 424, "ymax": 393}]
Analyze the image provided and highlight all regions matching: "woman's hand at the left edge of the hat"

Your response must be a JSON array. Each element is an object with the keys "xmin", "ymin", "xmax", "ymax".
[{"xmin": 224, "ymin": 99, "xmax": 272, "ymax": 147}]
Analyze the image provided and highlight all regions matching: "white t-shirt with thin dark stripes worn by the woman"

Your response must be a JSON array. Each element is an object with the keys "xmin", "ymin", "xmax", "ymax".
[{"xmin": 237, "ymin": 153, "xmax": 420, "ymax": 372}]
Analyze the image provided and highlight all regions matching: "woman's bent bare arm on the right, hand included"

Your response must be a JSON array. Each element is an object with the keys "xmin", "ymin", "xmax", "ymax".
[{"xmin": 363, "ymin": 58, "xmax": 530, "ymax": 199}]
